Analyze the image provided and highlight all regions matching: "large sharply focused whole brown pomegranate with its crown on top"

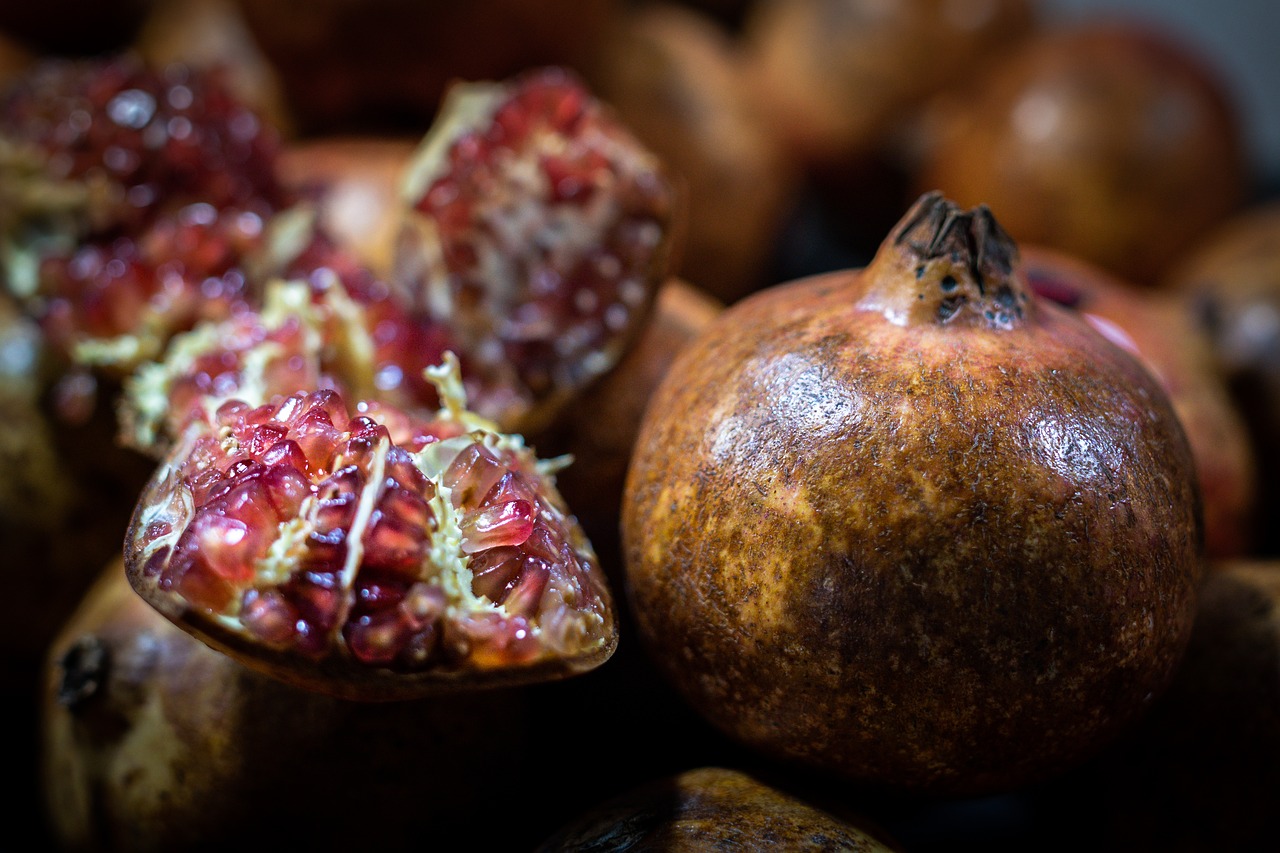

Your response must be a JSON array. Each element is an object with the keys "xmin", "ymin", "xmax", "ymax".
[{"xmin": 622, "ymin": 193, "xmax": 1202, "ymax": 793}]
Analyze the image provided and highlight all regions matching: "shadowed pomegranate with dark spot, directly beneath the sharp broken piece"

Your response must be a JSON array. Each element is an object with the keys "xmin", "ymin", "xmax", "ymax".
[{"xmin": 38, "ymin": 558, "xmax": 536, "ymax": 850}]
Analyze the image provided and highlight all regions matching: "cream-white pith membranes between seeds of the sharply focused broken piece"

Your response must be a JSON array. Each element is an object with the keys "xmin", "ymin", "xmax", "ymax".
[{"xmin": 133, "ymin": 335, "xmax": 609, "ymax": 666}]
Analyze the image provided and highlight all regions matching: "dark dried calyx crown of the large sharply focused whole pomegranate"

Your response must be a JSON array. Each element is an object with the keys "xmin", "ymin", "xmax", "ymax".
[{"xmin": 858, "ymin": 192, "xmax": 1032, "ymax": 330}]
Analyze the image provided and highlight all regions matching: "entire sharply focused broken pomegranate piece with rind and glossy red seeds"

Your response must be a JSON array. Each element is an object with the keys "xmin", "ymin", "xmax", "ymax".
[{"xmin": 125, "ymin": 360, "xmax": 617, "ymax": 699}]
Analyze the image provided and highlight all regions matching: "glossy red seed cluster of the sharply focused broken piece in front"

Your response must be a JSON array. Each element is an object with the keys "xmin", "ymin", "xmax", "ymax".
[{"xmin": 136, "ymin": 391, "xmax": 603, "ymax": 671}]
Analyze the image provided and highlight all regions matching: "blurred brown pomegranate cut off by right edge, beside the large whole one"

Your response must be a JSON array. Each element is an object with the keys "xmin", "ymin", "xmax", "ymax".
[{"xmin": 1161, "ymin": 202, "xmax": 1280, "ymax": 555}]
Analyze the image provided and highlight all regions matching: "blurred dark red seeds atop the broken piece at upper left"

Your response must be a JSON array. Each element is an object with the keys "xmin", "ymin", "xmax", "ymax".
[{"xmin": 0, "ymin": 56, "xmax": 285, "ymax": 236}]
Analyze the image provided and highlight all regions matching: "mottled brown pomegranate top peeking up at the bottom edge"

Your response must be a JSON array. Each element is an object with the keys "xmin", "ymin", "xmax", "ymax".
[{"xmin": 536, "ymin": 767, "xmax": 896, "ymax": 853}]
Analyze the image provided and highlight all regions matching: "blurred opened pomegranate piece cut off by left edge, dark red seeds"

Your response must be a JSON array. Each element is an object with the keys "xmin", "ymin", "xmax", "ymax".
[{"xmin": 0, "ymin": 56, "xmax": 287, "ymax": 374}]
